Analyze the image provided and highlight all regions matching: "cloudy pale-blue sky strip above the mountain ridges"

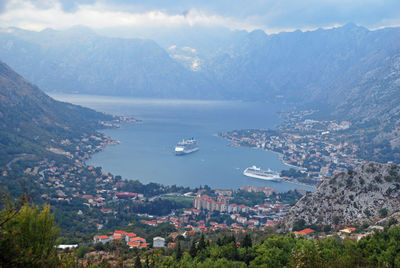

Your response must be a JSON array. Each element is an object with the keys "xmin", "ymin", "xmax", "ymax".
[{"xmin": 0, "ymin": 0, "xmax": 400, "ymax": 33}]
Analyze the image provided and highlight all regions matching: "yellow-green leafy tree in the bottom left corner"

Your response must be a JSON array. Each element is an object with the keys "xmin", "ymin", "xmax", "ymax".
[{"xmin": 0, "ymin": 203, "xmax": 59, "ymax": 267}]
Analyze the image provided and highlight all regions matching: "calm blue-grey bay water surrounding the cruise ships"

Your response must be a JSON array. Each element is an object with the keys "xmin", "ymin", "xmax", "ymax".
[{"xmin": 52, "ymin": 94, "xmax": 310, "ymax": 191}]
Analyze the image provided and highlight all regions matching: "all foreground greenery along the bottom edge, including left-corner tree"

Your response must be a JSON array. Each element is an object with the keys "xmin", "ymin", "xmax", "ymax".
[{"xmin": 0, "ymin": 192, "xmax": 400, "ymax": 267}]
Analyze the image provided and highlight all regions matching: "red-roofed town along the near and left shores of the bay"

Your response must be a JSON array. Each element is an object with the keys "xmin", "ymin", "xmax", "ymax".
[{"xmin": 1, "ymin": 118, "xmax": 305, "ymax": 247}]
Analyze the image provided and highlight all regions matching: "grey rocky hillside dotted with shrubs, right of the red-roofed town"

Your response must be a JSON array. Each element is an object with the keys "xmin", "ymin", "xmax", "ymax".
[{"xmin": 284, "ymin": 163, "xmax": 400, "ymax": 230}]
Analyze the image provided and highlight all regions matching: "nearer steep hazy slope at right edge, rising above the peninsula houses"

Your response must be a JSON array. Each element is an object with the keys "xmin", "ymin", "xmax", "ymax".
[{"xmin": 332, "ymin": 49, "xmax": 400, "ymax": 163}]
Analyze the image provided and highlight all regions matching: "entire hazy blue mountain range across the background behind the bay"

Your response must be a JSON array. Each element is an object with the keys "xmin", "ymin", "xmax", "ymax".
[{"xmin": 0, "ymin": 23, "xmax": 400, "ymax": 133}]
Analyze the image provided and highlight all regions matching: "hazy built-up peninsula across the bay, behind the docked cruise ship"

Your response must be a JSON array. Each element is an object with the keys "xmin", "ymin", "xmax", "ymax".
[{"xmin": 220, "ymin": 117, "xmax": 364, "ymax": 178}]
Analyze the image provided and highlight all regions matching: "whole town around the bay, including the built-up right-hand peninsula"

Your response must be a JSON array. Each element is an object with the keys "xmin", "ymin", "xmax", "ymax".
[{"xmin": 2, "ymin": 111, "xmax": 376, "ymax": 251}]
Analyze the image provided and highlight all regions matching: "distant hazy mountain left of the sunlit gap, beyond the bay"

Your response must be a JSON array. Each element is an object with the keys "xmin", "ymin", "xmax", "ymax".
[{"xmin": 0, "ymin": 27, "xmax": 215, "ymax": 98}]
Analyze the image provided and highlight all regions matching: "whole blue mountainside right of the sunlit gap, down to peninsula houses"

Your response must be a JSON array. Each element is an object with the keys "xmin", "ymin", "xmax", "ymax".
[{"xmin": 202, "ymin": 23, "xmax": 400, "ymax": 163}]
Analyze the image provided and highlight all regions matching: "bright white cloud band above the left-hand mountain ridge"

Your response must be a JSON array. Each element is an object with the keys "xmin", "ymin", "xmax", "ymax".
[{"xmin": 0, "ymin": 0, "xmax": 257, "ymax": 30}]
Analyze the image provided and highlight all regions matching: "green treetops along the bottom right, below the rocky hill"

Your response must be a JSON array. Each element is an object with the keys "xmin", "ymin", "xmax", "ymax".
[{"xmin": 149, "ymin": 227, "xmax": 400, "ymax": 267}]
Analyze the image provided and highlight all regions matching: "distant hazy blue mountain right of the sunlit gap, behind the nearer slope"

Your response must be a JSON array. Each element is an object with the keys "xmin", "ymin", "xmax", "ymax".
[{"xmin": 203, "ymin": 24, "xmax": 400, "ymax": 102}]
